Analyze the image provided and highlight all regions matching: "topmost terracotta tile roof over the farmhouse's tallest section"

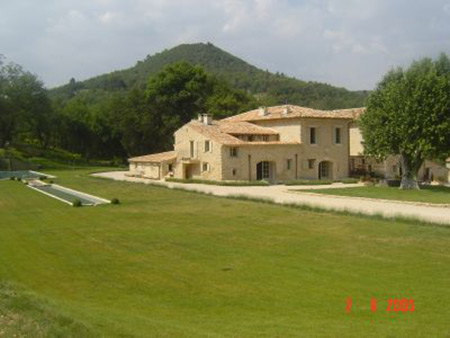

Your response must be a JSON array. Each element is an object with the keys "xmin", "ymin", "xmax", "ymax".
[{"xmin": 221, "ymin": 105, "xmax": 365, "ymax": 122}]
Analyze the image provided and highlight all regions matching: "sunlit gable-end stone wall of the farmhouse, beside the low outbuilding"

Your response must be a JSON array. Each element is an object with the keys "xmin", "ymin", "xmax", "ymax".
[{"xmin": 173, "ymin": 126, "xmax": 222, "ymax": 181}]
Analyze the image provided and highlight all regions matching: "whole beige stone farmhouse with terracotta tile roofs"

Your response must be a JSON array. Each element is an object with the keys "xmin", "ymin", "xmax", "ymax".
[{"xmin": 129, "ymin": 105, "xmax": 450, "ymax": 183}]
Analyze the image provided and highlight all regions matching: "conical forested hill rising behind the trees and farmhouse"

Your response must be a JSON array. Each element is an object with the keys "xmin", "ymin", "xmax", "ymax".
[{"xmin": 50, "ymin": 43, "xmax": 367, "ymax": 109}]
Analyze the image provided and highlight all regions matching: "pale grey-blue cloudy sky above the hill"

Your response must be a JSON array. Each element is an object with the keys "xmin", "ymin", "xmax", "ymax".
[{"xmin": 0, "ymin": 0, "xmax": 450, "ymax": 89}]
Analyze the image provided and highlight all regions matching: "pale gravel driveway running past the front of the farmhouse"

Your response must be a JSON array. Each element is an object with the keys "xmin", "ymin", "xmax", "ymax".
[{"xmin": 93, "ymin": 171, "xmax": 450, "ymax": 225}]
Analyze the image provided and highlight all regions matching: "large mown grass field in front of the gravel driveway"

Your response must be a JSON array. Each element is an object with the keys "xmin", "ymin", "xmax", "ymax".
[{"xmin": 0, "ymin": 170, "xmax": 450, "ymax": 337}]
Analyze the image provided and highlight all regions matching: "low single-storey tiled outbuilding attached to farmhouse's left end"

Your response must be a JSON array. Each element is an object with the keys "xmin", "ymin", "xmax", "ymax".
[{"xmin": 128, "ymin": 151, "xmax": 177, "ymax": 180}]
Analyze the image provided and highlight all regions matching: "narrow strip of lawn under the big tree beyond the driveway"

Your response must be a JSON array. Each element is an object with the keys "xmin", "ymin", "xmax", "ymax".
[{"xmin": 301, "ymin": 186, "xmax": 450, "ymax": 204}]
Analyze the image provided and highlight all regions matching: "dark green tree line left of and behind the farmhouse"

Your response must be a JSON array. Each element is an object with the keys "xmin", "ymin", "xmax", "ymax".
[{"xmin": 0, "ymin": 60, "xmax": 258, "ymax": 159}]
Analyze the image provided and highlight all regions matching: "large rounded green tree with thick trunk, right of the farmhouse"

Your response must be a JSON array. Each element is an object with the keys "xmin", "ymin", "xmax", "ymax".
[{"xmin": 360, "ymin": 54, "xmax": 450, "ymax": 189}]
